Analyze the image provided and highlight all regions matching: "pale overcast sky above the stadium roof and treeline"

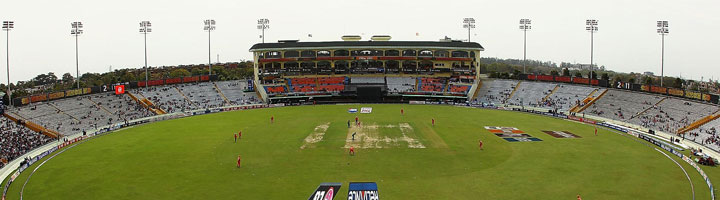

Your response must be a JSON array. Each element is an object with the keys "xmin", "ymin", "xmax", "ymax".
[{"xmin": 0, "ymin": 0, "xmax": 720, "ymax": 83}]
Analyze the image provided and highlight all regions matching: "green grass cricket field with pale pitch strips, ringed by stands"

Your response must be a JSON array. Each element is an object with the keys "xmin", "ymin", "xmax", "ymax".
[{"xmin": 1, "ymin": 105, "xmax": 717, "ymax": 200}]
